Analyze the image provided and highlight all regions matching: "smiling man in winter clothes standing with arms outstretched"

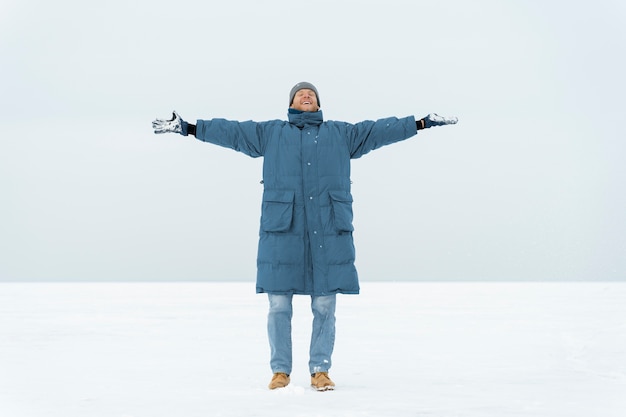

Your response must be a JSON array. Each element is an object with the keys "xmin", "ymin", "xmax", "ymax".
[{"xmin": 152, "ymin": 82, "xmax": 457, "ymax": 391}]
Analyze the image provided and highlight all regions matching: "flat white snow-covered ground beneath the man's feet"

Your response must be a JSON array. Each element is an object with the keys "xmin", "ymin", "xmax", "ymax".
[{"xmin": 0, "ymin": 282, "xmax": 626, "ymax": 417}]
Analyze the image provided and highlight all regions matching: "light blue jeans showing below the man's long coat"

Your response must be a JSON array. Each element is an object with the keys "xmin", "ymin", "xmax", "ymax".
[{"xmin": 267, "ymin": 294, "xmax": 337, "ymax": 375}]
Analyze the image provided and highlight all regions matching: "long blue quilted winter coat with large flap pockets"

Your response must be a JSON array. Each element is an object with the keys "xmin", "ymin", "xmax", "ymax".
[{"xmin": 196, "ymin": 109, "xmax": 417, "ymax": 295}]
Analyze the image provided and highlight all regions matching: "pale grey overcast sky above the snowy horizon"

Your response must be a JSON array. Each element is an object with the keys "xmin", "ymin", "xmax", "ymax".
[{"xmin": 0, "ymin": 0, "xmax": 626, "ymax": 282}]
